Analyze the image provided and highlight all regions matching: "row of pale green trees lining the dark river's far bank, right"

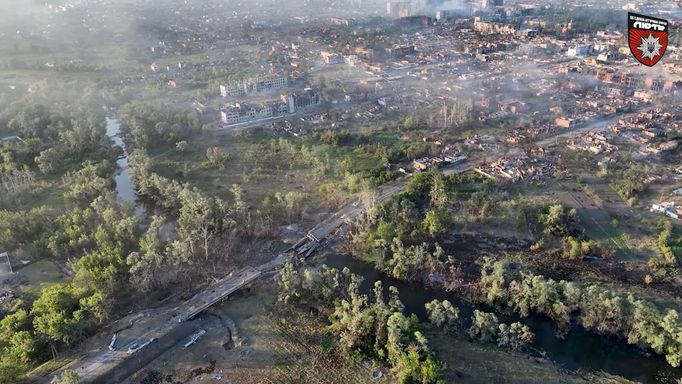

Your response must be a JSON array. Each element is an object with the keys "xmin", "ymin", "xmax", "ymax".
[{"xmin": 479, "ymin": 258, "xmax": 682, "ymax": 367}]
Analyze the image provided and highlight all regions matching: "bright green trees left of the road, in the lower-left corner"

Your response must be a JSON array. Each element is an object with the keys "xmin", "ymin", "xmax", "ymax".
[{"xmin": 0, "ymin": 194, "xmax": 139, "ymax": 382}]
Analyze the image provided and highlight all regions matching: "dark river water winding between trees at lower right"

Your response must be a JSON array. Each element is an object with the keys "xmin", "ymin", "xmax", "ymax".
[{"xmin": 323, "ymin": 254, "xmax": 682, "ymax": 384}]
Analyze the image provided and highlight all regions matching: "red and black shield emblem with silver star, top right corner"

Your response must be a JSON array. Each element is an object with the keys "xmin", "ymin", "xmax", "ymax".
[{"xmin": 628, "ymin": 13, "xmax": 668, "ymax": 67}]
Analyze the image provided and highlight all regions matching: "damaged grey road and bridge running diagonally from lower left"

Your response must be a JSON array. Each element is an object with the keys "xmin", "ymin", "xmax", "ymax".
[{"xmin": 38, "ymin": 160, "xmax": 471, "ymax": 384}]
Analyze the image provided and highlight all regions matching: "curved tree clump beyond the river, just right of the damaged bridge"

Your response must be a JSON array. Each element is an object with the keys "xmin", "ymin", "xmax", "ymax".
[{"xmin": 350, "ymin": 173, "xmax": 609, "ymax": 282}]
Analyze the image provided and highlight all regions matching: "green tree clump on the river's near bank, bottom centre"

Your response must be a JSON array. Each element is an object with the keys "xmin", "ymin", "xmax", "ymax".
[{"xmin": 279, "ymin": 264, "xmax": 444, "ymax": 384}]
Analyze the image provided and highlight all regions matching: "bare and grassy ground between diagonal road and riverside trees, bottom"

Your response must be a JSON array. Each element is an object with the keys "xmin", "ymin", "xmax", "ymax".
[{"xmin": 125, "ymin": 283, "xmax": 388, "ymax": 384}]
